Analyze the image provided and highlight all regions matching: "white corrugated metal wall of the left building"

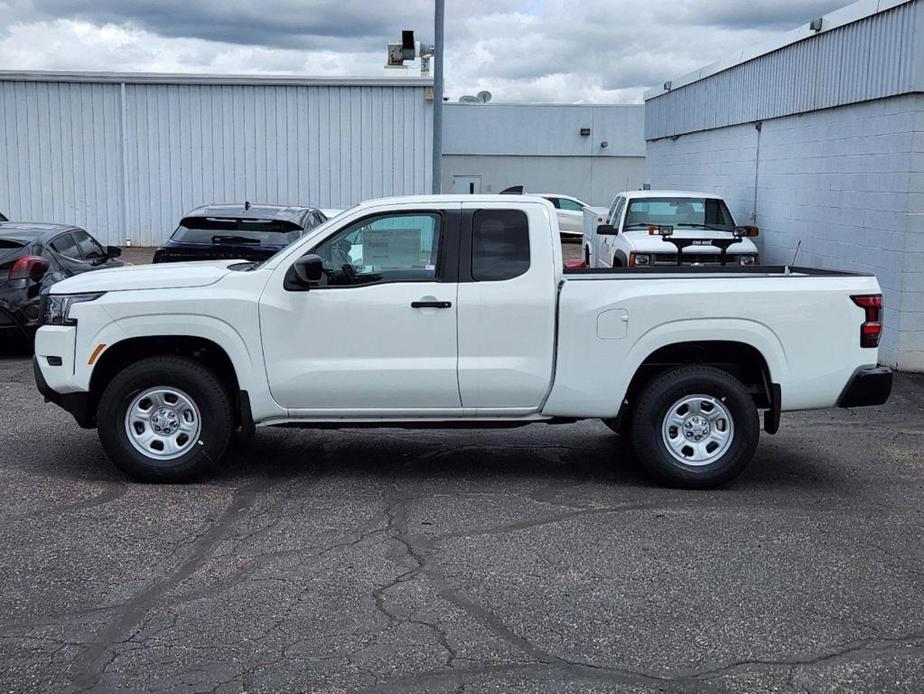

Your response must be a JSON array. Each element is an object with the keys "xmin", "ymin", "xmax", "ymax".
[{"xmin": 0, "ymin": 74, "xmax": 432, "ymax": 245}]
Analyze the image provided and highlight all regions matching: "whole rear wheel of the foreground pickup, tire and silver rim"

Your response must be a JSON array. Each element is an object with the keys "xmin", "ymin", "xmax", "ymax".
[{"xmin": 632, "ymin": 366, "xmax": 760, "ymax": 489}]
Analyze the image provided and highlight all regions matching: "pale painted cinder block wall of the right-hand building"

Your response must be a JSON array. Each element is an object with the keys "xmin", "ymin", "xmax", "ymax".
[{"xmin": 647, "ymin": 94, "xmax": 924, "ymax": 371}]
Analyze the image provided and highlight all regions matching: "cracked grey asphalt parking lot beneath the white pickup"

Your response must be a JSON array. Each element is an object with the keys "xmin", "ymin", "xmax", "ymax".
[{"xmin": 0, "ymin": 324, "xmax": 924, "ymax": 692}]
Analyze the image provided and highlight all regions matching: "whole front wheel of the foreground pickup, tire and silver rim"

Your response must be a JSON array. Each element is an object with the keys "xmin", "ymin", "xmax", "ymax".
[{"xmin": 97, "ymin": 357, "xmax": 234, "ymax": 482}]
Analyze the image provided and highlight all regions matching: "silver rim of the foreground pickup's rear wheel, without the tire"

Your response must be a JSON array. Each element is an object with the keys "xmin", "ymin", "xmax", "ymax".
[{"xmin": 661, "ymin": 395, "xmax": 735, "ymax": 467}]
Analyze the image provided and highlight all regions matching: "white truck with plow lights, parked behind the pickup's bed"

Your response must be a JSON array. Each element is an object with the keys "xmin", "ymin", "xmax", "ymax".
[{"xmin": 583, "ymin": 190, "xmax": 760, "ymax": 268}]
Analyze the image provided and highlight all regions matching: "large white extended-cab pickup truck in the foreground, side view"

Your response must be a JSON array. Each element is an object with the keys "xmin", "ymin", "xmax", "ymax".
[{"xmin": 35, "ymin": 195, "xmax": 891, "ymax": 487}]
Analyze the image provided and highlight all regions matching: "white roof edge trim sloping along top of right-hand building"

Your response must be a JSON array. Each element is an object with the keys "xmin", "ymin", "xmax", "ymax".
[{"xmin": 642, "ymin": 0, "xmax": 918, "ymax": 101}]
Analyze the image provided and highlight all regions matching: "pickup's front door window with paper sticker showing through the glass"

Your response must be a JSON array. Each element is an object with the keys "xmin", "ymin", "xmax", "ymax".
[{"xmin": 314, "ymin": 213, "xmax": 441, "ymax": 287}]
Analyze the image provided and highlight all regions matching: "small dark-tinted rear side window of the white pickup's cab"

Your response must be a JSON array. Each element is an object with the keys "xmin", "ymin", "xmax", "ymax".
[{"xmin": 472, "ymin": 210, "xmax": 529, "ymax": 282}]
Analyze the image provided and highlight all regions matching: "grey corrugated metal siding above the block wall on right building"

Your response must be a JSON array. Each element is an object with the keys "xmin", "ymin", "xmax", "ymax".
[{"xmin": 645, "ymin": 0, "xmax": 924, "ymax": 140}]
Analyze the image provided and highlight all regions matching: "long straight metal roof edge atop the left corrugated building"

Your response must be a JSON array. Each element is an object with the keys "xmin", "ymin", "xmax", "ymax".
[{"xmin": 0, "ymin": 70, "xmax": 433, "ymax": 87}]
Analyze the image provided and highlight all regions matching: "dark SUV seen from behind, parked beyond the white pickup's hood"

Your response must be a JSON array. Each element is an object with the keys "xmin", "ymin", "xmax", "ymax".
[{"xmin": 154, "ymin": 202, "xmax": 327, "ymax": 263}]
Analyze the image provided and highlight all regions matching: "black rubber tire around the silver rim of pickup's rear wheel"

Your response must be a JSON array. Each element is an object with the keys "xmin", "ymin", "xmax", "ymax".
[{"xmin": 632, "ymin": 366, "xmax": 760, "ymax": 489}]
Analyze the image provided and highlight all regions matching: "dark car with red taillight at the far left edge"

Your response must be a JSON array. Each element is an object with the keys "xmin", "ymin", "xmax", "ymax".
[{"xmin": 0, "ymin": 222, "xmax": 125, "ymax": 336}]
